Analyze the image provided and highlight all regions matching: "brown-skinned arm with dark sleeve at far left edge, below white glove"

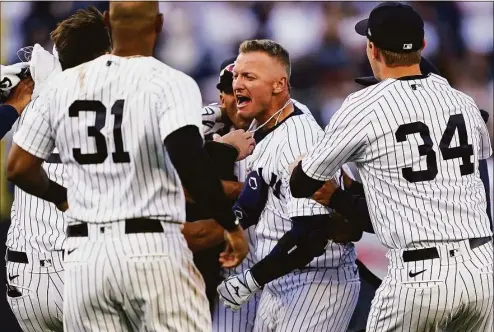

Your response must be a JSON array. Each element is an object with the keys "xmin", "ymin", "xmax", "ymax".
[{"xmin": 0, "ymin": 78, "xmax": 34, "ymax": 139}]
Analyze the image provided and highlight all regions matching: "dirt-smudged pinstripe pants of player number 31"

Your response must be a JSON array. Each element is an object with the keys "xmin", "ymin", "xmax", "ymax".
[{"xmin": 64, "ymin": 221, "xmax": 211, "ymax": 332}]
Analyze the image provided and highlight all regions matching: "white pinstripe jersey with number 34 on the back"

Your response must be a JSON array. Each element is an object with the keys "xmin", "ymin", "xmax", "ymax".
[{"xmin": 302, "ymin": 74, "xmax": 492, "ymax": 249}]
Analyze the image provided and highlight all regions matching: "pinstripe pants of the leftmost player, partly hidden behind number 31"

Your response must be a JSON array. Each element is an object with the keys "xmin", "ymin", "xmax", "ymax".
[{"xmin": 6, "ymin": 251, "xmax": 64, "ymax": 332}]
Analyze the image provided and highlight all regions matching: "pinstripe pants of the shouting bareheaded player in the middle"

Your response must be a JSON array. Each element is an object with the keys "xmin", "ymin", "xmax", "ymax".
[{"xmin": 254, "ymin": 264, "xmax": 360, "ymax": 332}]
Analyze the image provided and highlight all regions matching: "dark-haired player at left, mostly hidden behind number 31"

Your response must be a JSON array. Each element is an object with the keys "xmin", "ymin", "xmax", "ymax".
[{"xmin": 6, "ymin": 8, "xmax": 110, "ymax": 331}]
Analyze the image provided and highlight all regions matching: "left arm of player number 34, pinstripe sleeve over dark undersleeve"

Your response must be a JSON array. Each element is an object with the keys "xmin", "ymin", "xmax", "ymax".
[{"xmin": 290, "ymin": 98, "xmax": 370, "ymax": 198}]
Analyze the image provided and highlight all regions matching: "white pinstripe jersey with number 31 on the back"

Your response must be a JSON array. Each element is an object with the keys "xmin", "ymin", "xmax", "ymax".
[{"xmin": 14, "ymin": 55, "xmax": 202, "ymax": 223}]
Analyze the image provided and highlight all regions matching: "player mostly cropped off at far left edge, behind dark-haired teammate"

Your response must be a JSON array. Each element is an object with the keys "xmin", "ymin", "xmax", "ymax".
[{"xmin": 0, "ymin": 62, "xmax": 34, "ymax": 139}]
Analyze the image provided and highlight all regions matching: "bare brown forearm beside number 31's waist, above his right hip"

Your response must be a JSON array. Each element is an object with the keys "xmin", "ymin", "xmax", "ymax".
[{"xmin": 182, "ymin": 219, "xmax": 225, "ymax": 252}]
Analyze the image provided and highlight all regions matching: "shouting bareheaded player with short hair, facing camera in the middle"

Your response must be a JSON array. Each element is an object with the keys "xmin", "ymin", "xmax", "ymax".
[{"xmin": 218, "ymin": 40, "xmax": 360, "ymax": 331}]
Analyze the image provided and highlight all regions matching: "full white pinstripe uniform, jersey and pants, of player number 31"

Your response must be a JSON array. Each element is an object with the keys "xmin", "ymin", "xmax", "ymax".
[{"xmin": 14, "ymin": 55, "xmax": 211, "ymax": 331}]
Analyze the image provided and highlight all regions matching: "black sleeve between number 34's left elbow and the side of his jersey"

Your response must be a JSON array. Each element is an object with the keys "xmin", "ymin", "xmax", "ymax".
[{"xmin": 328, "ymin": 187, "xmax": 374, "ymax": 233}]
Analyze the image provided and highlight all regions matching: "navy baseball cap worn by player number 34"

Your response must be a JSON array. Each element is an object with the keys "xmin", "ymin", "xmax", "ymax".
[{"xmin": 355, "ymin": 2, "xmax": 424, "ymax": 53}]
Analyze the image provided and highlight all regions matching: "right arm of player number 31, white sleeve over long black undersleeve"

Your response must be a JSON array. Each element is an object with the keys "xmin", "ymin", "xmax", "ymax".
[{"xmin": 156, "ymin": 77, "xmax": 248, "ymax": 267}]
